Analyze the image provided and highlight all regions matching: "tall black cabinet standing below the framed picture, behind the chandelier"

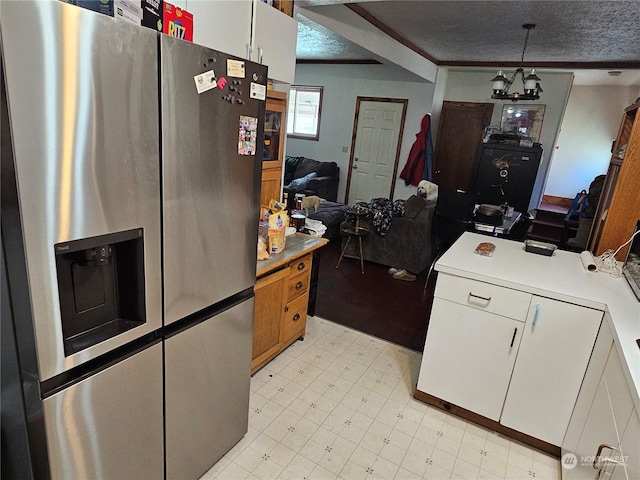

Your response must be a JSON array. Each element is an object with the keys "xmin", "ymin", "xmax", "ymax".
[{"xmin": 473, "ymin": 143, "xmax": 542, "ymax": 213}]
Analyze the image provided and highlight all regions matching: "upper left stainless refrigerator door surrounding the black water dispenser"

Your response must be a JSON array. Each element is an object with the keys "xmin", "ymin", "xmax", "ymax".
[{"xmin": 2, "ymin": 0, "xmax": 162, "ymax": 381}]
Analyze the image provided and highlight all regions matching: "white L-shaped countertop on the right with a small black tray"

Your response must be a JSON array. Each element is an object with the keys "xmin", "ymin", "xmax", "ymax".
[{"xmin": 435, "ymin": 232, "xmax": 640, "ymax": 411}]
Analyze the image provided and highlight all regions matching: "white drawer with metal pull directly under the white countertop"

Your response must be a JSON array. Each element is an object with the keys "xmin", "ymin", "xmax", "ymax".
[{"xmin": 434, "ymin": 273, "xmax": 531, "ymax": 322}]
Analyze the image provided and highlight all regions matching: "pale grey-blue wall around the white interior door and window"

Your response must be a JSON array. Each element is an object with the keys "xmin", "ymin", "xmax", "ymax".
[{"xmin": 285, "ymin": 64, "xmax": 435, "ymax": 202}]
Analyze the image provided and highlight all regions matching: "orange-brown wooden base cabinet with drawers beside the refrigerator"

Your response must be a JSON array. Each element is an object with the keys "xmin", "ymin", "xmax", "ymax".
[{"xmin": 251, "ymin": 253, "xmax": 312, "ymax": 373}]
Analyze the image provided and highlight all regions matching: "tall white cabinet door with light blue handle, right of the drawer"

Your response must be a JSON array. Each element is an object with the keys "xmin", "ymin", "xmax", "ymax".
[{"xmin": 500, "ymin": 297, "xmax": 603, "ymax": 445}]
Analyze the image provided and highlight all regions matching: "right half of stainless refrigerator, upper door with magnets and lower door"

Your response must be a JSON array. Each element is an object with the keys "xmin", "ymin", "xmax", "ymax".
[{"xmin": 160, "ymin": 36, "xmax": 267, "ymax": 478}]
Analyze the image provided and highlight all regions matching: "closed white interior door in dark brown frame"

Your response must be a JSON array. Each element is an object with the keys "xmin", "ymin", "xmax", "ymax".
[{"xmin": 347, "ymin": 97, "xmax": 407, "ymax": 205}]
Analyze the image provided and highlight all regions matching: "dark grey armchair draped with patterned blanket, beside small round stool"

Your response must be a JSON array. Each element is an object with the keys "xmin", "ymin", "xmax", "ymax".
[{"xmin": 340, "ymin": 195, "xmax": 436, "ymax": 274}]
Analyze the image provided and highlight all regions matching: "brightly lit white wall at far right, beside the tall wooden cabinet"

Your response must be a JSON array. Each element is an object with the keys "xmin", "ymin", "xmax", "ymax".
[{"xmin": 544, "ymin": 86, "xmax": 638, "ymax": 198}]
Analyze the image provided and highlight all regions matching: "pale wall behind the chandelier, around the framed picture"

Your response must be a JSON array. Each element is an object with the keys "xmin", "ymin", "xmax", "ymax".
[{"xmin": 444, "ymin": 70, "xmax": 573, "ymax": 209}]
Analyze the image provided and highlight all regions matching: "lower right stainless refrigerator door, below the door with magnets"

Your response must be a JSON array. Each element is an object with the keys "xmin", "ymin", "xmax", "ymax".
[{"xmin": 165, "ymin": 297, "xmax": 253, "ymax": 479}]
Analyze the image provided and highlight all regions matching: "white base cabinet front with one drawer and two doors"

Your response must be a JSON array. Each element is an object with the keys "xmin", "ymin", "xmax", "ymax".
[{"xmin": 416, "ymin": 273, "xmax": 603, "ymax": 446}]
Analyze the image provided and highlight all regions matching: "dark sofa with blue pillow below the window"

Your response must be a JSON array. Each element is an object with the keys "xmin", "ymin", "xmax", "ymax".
[{"xmin": 282, "ymin": 156, "xmax": 340, "ymax": 205}]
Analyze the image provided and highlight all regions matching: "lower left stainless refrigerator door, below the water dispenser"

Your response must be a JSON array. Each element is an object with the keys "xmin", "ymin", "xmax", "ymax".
[{"xmin": 44, "ymin": 343, "xmax": 164, "ymax": 480}]
